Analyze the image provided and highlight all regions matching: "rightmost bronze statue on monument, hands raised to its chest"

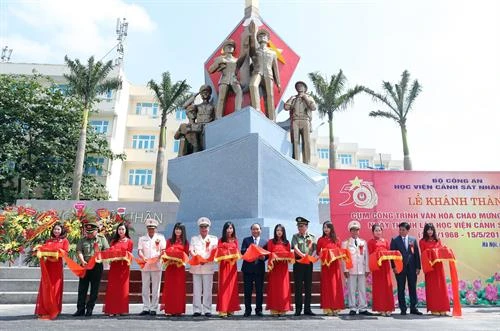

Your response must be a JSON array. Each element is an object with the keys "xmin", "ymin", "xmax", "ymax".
[{"xmin": 284, "ymin": 81, "xmax": 316, "ymax": 164}]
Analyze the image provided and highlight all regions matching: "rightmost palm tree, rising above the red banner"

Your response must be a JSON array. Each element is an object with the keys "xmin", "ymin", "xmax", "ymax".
[{"xmin": 365, "ymin": 70, "xmax": 422, "ymax": 170}]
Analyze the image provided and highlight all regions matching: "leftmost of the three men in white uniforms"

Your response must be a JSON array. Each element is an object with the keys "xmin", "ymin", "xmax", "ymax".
[{"xmin": 137, "ymin": 218, "xmax": 167, "ymax": 316}]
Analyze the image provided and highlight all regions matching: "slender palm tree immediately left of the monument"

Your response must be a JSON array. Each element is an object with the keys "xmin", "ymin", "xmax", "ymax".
[{"xmin": 148, "ymin": 71, "xmax": 191, "ymax": 201}]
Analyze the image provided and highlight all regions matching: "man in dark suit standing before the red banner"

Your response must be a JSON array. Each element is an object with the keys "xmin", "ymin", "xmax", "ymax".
[{"xmin": 391, "ymin": 222, "xmax": 422, "ymax": 315}]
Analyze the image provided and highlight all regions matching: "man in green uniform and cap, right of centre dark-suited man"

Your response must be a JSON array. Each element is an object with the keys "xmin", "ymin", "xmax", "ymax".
[{"xmin": 292, "ymin": 216, "xmax": 316, "ymax": 316}]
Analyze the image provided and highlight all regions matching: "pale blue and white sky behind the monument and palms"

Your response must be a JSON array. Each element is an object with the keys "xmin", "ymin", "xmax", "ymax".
[{"xmin": 0, "ymin": 0, "xmax": 500, "ymax": 171}]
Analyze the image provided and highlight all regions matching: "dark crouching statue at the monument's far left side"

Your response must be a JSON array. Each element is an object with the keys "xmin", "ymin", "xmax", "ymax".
[{"xmin": 174, "ymin": 85, "xmax": 215, "ymax": 156}]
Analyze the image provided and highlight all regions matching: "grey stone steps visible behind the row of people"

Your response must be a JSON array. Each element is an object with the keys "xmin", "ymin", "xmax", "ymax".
[{"xmin": 0, "ymin": 267, "xmax": 320, "ymax": 304}]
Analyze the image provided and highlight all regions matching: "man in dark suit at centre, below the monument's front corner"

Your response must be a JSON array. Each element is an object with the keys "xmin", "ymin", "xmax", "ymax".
[{"xmin": 241, "ymin": 223, "xmax": 267, "ymax": 317}]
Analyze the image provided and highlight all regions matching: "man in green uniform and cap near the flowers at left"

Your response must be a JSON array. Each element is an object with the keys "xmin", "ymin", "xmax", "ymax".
[{"xmin": 73, "ymin": 220, "xmax": 109, "ymax": 316}]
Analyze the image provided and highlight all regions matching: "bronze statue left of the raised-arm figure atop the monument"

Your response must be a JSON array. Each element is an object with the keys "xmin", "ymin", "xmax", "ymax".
[{"xmin": 208, "ymin": 39, "xmax": 243, "ymax": 119}]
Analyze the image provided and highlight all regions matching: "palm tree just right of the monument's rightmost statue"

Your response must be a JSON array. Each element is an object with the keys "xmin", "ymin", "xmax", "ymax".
[{"xmin": 309, "ymin": 69, "xmax": 364, "ymax": 169}]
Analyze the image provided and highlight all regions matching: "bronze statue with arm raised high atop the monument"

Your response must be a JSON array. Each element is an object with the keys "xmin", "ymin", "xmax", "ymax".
[{"xmin": 249, "ymin": 21, "xmax": 281, "ymax": 122}]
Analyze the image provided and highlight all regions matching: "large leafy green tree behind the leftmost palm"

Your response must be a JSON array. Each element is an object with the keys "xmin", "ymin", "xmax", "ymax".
[{"xmin": 0, "ymin": 75, "xmax": 121, "ymax": 203}]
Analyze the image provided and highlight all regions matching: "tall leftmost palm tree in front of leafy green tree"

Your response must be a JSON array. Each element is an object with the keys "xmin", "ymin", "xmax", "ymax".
[{"xmin": 64, "ymin": 55, "xmax": 121, "ymax": 200}]
